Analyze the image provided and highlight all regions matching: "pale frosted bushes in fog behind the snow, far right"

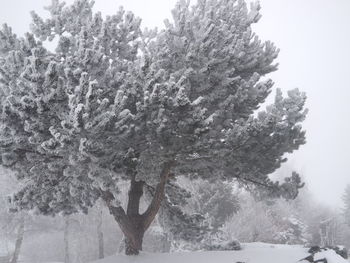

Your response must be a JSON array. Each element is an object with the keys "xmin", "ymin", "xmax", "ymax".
[{"xmin": 222, "ymin": 188, "xmax": 350, "ymax": 250}]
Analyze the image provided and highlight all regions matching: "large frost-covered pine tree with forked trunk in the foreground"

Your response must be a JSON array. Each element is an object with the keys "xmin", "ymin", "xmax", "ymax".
[{"xmin": 0, "ymin": 0, "xmax": 306, "ymax": 254}]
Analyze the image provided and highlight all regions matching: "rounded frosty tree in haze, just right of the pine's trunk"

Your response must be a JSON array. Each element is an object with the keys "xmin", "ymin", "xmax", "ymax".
[{"xmin": 154, "ymin": 177, "xmax": 239, "ymax": 250}]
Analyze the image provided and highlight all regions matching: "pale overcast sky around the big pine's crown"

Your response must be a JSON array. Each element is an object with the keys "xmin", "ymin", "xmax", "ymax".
[{"xmin": 0, "ymin": 0, "xmax": 350, "ymax": 209}]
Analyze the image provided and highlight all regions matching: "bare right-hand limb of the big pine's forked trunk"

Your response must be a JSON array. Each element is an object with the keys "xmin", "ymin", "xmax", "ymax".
[{"xmin": 142, "ymin": 161, "xmax": 175, "ymax": 230}]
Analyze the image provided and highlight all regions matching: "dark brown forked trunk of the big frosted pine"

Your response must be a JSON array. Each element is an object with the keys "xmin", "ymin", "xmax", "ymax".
[{"xmin": 102, "ymin": 161, "xmax": 174, "ymax": 255}]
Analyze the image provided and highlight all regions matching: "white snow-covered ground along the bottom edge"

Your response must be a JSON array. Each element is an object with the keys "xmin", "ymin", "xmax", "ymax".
[{"xmin": 94, "ymin": 243, "xmax": 349, "ymax": 263}]
